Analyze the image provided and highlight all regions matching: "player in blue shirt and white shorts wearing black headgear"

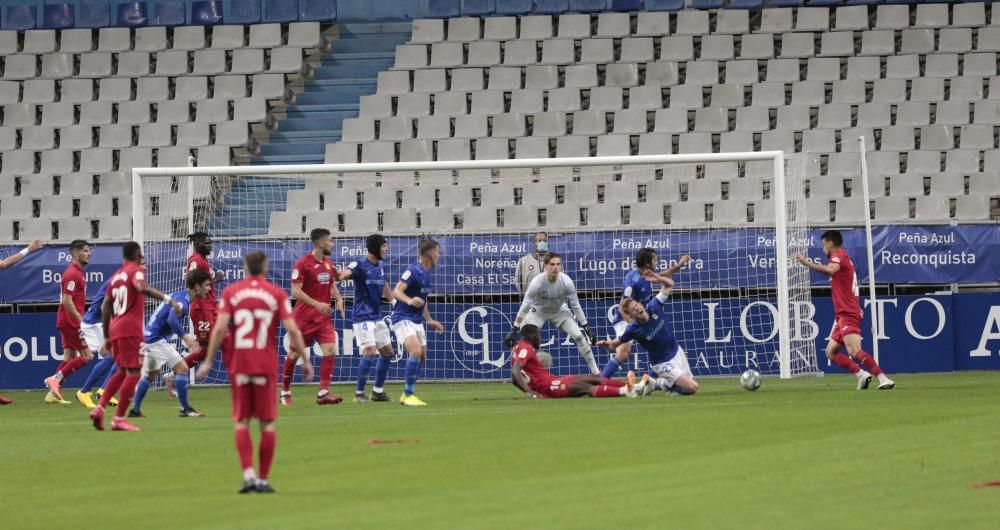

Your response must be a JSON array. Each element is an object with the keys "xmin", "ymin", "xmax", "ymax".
[{"xmin": 337, "ymin": 234, "xmax": 395, "ymax": 403}]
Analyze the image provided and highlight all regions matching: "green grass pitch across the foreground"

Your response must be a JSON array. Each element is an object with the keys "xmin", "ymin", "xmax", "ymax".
[{"xmin": 0, "ymin": 373, "xmax": 1000, "ymax": 530}]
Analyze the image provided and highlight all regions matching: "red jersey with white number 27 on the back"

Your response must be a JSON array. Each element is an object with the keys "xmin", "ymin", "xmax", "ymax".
[{"xmin": 219, "ymin": 276, "xmax": 292, "ymax": 376}]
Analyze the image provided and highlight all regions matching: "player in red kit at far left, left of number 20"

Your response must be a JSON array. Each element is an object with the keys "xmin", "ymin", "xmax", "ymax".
[{"xmin": 45, "ymin": 239, "xmax": 94, "ymax": 405}]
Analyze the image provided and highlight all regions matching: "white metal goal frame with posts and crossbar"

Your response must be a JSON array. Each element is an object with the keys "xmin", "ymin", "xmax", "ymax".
[{"xmin": 132, "ymin": 151, "xmax": 804, "ymax": 379}]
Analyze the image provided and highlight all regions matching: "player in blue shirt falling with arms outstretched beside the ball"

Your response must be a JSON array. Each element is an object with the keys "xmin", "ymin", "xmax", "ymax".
[{"xmin": 597, "ymin": 275, "xmax": 698, "ymax": 396}]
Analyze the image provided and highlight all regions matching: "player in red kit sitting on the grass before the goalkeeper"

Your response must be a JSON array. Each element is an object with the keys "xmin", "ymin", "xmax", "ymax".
[{"xmin": 510, "ymin": 324, "xmax": 636, "ymax": 399}]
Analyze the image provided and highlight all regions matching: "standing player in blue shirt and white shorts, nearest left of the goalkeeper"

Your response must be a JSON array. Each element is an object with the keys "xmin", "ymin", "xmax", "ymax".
[{"xmin": 392, "ymin": 239, "xmax": 444, "ymax": 407}]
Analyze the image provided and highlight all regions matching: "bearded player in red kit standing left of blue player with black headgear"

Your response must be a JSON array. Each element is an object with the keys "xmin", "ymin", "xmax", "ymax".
[{"xmin": 281, "ymin": 228, "xmax": 345, "ymax": 405}]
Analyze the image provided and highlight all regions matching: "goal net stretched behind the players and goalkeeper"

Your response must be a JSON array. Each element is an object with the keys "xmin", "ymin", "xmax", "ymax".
[{"xmin": 133, "ymin": 153, "xmax": 819, "ymax": 383}]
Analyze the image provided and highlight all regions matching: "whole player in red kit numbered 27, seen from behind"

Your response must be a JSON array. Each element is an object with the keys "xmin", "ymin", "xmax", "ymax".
[{"xmin": 197, "ymin": 252, "xmax": 305, "ymax": 493}]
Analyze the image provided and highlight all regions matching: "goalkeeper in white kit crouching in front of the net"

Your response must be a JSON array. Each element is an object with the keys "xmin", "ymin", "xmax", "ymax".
[{"xmin": 504, "ymin": 252, "xmax": 601, "ymax": 375}]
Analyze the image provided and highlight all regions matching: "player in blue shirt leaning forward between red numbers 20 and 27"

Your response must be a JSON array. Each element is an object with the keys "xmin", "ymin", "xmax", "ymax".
[{"xmin": 128, "ymin": 269, "xmax": 212, "ymax": 418}]
